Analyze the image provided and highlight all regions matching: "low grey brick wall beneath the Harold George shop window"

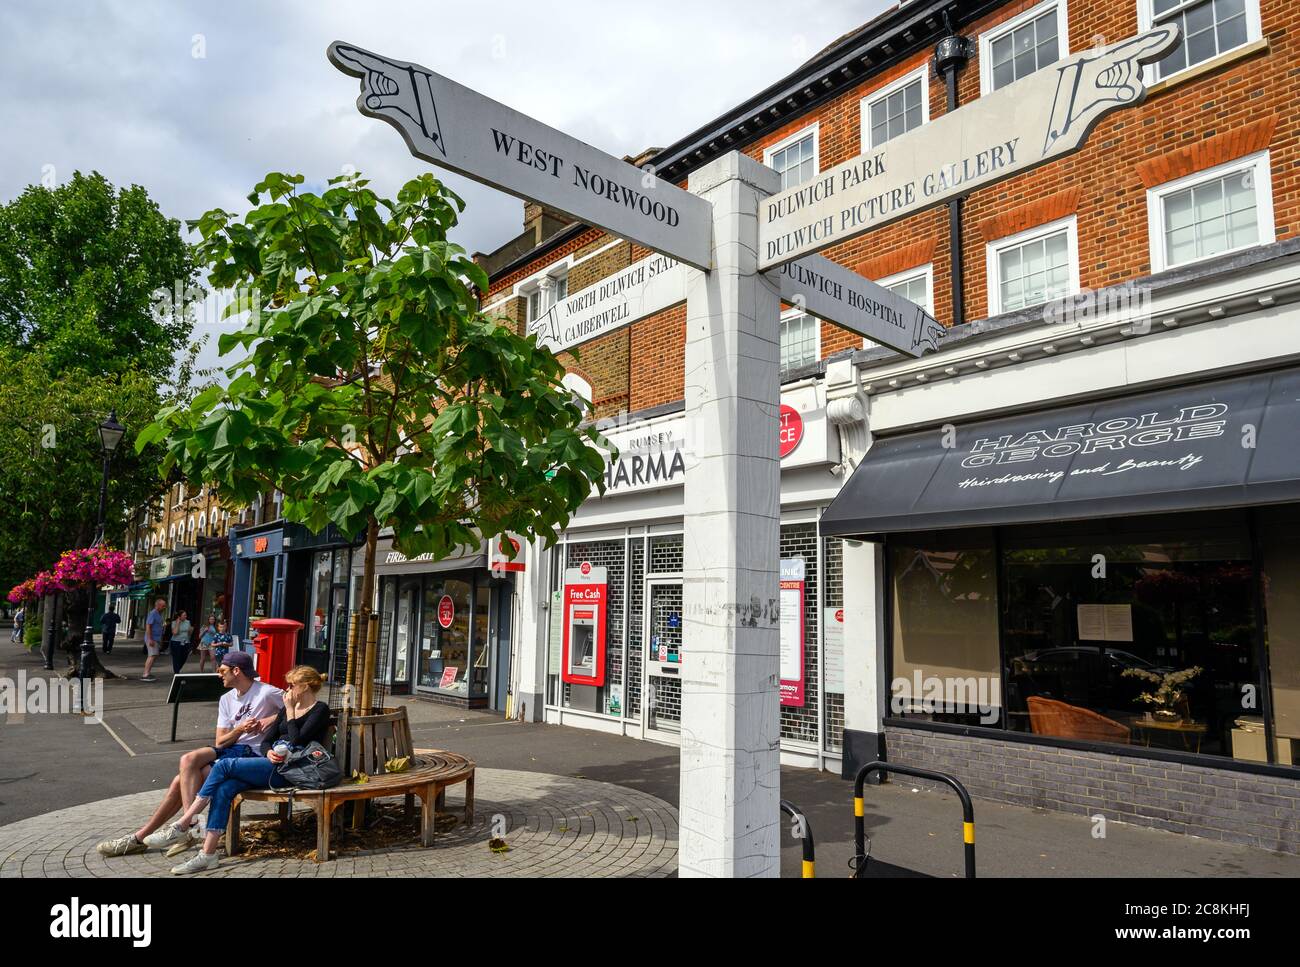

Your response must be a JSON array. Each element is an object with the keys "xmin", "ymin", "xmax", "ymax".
[{"xmin": 885, "ymin": 725, "xmax": 1300, "ymax": 854}]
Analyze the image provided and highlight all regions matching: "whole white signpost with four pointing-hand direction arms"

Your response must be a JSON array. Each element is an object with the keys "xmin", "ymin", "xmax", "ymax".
[{"xmin": 329, "ymin": 26, "xmax": 1178, "ymax": 876}]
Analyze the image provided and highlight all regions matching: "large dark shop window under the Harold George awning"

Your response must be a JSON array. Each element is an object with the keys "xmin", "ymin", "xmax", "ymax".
[{"xmin": 889, "ymin": 512, "xmax": 1279, "ymax": 763}]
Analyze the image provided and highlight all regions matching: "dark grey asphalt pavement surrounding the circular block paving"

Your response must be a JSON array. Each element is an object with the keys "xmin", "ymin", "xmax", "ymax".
[{"xmin": 0, "ymin": 643, "xmax": 1300, "ymax": 877}]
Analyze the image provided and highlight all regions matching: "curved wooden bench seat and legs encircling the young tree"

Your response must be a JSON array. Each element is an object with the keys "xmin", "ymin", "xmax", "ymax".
[{"xmin": 226, "ymin": 749, "xmax": 475, "ymax": 863}]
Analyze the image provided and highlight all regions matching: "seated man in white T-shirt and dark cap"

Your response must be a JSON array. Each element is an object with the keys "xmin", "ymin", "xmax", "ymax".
[{"xmin": 95, "ymin": 651, "xmax": 285, "ymax": 857}]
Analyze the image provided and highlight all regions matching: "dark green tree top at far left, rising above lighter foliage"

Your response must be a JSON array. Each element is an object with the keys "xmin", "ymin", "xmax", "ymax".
[{"xmin": 0, "ymin": 172, "xmax": 203, "ymax": 380}]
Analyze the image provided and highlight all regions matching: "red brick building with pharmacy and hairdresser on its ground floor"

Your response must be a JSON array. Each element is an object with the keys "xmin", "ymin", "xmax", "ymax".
[{"xmin": 481, "ymin": 0, "xmax": 1300, "ymax": 851}]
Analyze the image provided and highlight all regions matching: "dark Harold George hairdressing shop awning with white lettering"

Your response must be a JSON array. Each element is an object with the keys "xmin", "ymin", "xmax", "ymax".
[{"xmin": 822, "ymin": 369, "xmax": 1300, "ymax": 538}]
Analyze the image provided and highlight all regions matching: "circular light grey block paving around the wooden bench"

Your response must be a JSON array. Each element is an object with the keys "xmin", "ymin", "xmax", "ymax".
[{"xmin": 0, "ymin": 768, "xmax": 677, "ymax": 877}]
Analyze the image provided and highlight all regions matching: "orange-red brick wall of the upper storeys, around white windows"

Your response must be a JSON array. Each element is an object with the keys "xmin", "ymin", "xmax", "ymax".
[{"xmin": 493, "ymin": 0, "xmax": 1300, "ymax": 409}]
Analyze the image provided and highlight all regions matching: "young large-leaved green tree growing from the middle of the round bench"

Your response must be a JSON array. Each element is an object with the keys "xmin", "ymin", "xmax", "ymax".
[{"xmin": 137, "ymin": 173, "xmax": 605, "ymax": 688}]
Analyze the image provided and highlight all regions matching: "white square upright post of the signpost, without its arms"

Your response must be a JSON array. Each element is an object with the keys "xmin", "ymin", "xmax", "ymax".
[{"xmin": 679, "ymin": 152, "xmax": 781, "ymax": 877}]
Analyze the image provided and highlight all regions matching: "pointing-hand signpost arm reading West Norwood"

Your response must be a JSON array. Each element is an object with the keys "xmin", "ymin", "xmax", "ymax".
[{"xmin": 329, "ymin": 42, "xmax": 712, "ymax": 270}]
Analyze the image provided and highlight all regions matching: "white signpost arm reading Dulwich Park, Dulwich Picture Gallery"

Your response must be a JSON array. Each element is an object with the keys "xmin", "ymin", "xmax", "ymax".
[{"xmin": 758, "ymin": 26, "xmax": 1178, "ymax": 269}]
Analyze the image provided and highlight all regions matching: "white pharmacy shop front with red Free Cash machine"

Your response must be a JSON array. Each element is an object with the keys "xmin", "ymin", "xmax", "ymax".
[{"xmin": 536, "ymin": 382, "xmax": 844, "ymax": 768}]
